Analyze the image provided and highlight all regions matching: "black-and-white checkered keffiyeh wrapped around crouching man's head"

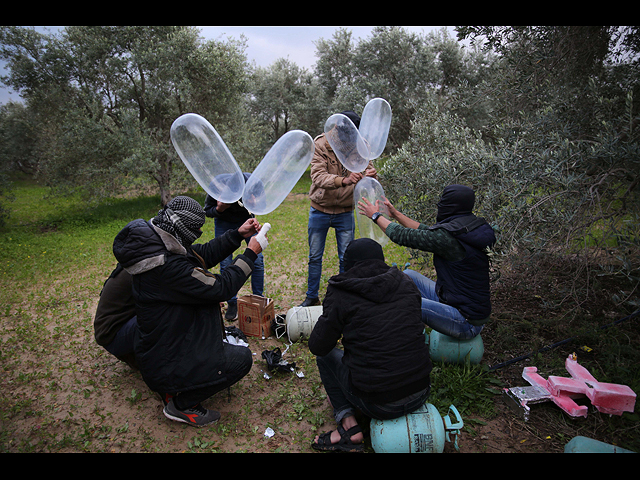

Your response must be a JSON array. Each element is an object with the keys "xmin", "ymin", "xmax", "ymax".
[{"xmin": 153, "ymin": 197, "xmax": 205, "ymax": 247}]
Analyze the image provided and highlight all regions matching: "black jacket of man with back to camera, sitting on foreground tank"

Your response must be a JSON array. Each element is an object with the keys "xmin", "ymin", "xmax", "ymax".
[{"xmin": 308, "ymin": 260, "xmax": 431, "ymax": 403}]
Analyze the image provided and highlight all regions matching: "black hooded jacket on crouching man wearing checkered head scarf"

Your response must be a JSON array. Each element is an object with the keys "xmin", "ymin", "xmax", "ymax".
[{"xmin": 113, "ymin": 219, "xmax": 255, "ymax": 394}]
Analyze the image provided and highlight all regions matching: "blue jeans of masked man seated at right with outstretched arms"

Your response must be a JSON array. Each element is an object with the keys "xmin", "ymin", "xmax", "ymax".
[{"xmin": 404, "ymin": 269, "xmax": 483, "ymax": 340}]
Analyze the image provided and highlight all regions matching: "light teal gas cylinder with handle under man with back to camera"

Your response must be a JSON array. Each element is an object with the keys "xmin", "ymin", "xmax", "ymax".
[{"xmin": 369, "ymin": 403, "xmax": 464, "ymax": 453}]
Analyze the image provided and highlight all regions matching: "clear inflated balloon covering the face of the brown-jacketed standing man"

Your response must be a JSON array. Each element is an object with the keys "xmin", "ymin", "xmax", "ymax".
[{"xmin": 324, "ymin": 113, "xmax": 369, "ymax": 173}]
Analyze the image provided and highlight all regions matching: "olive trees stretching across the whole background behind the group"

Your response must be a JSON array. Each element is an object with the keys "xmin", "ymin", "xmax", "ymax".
[{"xmin": 5, "ymin": 26, "xmax": 640, "ymax": 316}]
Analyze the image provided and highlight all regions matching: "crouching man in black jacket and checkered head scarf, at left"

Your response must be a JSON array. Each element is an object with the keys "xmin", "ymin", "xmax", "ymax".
[{"xmin": 113, "ymin": 197, "xmax": 262, "ymax": 426}]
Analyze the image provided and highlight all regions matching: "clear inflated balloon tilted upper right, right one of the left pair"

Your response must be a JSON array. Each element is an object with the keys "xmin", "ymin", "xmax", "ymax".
[{"xmin": 242, "ymin": 130, "xmax": 315, "ymax": 215}]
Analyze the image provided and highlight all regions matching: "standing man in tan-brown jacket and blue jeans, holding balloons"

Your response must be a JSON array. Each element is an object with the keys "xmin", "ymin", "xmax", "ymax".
[{"xmin": 300, "ymin": 111, "xmax": 377, "ymax": 307}]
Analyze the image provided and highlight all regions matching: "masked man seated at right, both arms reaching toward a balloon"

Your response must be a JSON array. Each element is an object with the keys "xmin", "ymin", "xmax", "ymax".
[{"xmin": 358, "ymin": 185, "xmax": 496, "ymax": 340}]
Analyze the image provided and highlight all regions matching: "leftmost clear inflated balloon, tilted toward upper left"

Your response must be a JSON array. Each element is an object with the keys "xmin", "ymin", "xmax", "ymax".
[{"xmin": 171, "ymin": 113, "xmax": 244, "ymax": 203}]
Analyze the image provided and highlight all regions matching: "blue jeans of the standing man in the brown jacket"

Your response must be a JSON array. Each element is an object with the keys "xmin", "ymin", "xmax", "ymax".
[{"xmin": 307, "ymin": 207, "xmax": 355, "ymax": 298}]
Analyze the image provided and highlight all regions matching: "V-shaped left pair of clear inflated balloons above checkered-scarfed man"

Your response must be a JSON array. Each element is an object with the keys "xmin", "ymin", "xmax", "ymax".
[{"xmin": 171, "ymin": 113, "xmax": 314, "ymax": 215}]
